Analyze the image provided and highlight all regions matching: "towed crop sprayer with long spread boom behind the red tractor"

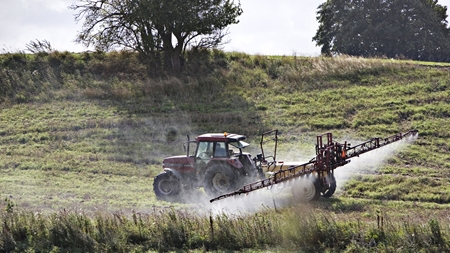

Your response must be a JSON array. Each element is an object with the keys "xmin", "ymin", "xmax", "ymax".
[{"xmin": 210, "ymin": 130, "xmax": 418, "ymax": 202}]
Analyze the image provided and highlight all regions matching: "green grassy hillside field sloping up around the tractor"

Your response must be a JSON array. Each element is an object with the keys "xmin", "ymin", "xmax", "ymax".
[{"xmin": 0, "ymin": 51, "xmax": 450, "ymax": 252}]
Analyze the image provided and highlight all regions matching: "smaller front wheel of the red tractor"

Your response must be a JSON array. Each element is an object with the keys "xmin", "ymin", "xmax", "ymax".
[{"xmin": 153, "ymin": 172, "xmax": 181, "ymax": 201}]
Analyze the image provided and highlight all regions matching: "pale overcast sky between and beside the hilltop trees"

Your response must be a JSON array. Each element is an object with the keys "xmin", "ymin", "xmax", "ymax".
[{"xmin": 0, "ymin": 0, "xmax": 450, "ymax": 56}]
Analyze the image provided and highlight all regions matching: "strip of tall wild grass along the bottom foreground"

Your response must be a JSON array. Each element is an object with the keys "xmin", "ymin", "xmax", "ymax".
[{"xmin": 0, "ymin": 207, "xmax": 450, "ymax": 252}]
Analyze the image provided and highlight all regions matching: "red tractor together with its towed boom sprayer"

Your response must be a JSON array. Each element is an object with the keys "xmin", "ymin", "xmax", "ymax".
[{"xmin": 153, "ymin": 130, "xmax": 418, "ymax": 202}]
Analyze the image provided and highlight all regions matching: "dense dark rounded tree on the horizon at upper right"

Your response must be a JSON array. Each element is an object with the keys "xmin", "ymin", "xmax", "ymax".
[{"xmin": 313, "ymin": 0, "xmax": 450, "ymax": 61}]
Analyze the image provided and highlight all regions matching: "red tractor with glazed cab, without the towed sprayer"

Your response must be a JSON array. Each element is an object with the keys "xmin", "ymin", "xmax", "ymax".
[{"xmin": 153, "ymin": 133, "xmax": 264, "ymax": 200}]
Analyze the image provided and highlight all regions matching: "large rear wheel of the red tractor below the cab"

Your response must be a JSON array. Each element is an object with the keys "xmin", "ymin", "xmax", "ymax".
[{"xmin": 203, "ymin": 164, "xmax": 237, "ymax": 198}]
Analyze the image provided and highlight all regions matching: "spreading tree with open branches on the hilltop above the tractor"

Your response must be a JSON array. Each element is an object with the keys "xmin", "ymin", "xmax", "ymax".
[{"xmin": 71, "ymin": 0, "xmax": 242, "ymax": 70}]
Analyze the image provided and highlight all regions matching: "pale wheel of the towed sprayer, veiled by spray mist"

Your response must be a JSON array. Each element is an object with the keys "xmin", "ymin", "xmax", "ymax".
[{"xmin": 291, "ymin": 176, "xmax": 320, "ymax": 202}]
